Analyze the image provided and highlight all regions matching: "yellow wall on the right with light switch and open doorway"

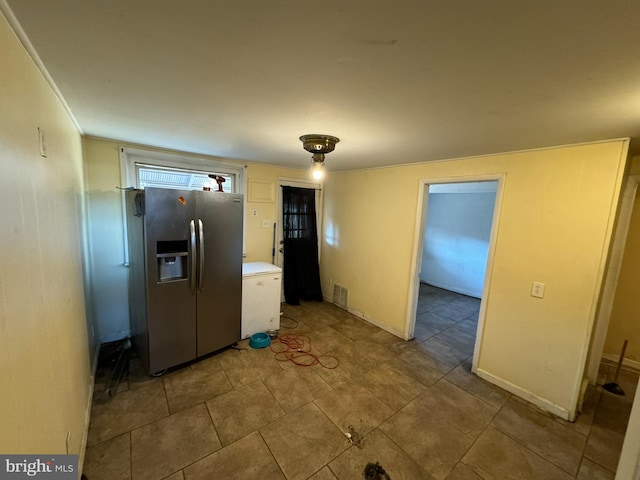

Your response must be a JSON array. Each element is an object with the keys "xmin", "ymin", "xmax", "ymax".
[{"xmin": 321, "ymin": 141, "xmax": 628, "ymax": 416}]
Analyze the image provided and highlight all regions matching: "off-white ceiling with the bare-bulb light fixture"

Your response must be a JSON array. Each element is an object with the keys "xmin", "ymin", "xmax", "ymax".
[{"xmin": 5, "ymin": 0, "xmax": 640, "ymax": 170}]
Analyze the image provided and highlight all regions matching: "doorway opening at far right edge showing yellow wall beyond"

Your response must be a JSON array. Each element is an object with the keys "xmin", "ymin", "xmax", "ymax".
[{"xmin": 578, "ymin": 175, "xmax": 640, "ymax": 479}]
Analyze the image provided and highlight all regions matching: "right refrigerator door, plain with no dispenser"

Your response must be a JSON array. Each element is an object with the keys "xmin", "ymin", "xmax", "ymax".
[{"xmin": 194, "ymin": 192, "xmax": 243, "ymax": 356}]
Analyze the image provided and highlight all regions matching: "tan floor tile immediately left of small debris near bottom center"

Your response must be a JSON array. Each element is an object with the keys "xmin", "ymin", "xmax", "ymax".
[{"xmin": 260, "ymin": 403, "xmax": 349, "ymax": 480}]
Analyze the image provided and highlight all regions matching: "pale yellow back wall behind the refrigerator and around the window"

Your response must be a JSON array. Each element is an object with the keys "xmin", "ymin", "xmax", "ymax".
[{"xmin": 83, "ymin": 137, "xmax": 308, "ymax": 341}]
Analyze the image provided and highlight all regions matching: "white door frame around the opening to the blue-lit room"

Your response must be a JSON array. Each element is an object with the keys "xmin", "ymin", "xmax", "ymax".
[{"xmin": 404, "ymin": 173, "xmax": 506, "ymax": 373}]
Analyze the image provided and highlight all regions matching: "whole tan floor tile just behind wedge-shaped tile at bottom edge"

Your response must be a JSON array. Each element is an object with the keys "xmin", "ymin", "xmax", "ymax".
[{"xmin": 207, "ymin": 380, "xmax": 285, "ymax": 446}]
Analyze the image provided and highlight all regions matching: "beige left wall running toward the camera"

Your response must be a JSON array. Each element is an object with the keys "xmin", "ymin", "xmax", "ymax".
[{"xmin": 0, "ymin": 10, "xmax": 91, "ymax": 454}]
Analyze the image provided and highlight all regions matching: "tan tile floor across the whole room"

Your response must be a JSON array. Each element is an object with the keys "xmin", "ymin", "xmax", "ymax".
[{"xmin": 84, "ymin": 285, "xmax": 638, "ymax": 480}]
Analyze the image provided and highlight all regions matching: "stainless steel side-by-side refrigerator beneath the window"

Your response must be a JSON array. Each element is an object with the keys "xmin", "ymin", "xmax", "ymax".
[{"xmin": 126, "ymin": 188, "xmax": 243, "ymax": 374}]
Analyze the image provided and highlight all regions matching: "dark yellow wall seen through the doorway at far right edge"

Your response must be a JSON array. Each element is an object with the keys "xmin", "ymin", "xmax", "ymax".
[{"xmin": 604, "ymin": 189, "xmax": 640, "ymax": 367}]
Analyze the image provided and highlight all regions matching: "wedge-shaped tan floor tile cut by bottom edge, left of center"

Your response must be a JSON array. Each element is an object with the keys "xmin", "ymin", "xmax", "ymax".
[{"xmin": 184, "ymin": 432, "xmax": 285, "ymax": 480}]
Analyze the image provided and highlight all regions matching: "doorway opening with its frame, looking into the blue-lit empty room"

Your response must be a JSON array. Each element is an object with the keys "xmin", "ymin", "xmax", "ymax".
[{"xmin": 406, "ymin": 176, "xmax": 502, "ymax": 371}]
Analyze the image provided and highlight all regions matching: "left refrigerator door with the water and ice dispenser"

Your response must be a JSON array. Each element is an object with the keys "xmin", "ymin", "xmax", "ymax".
[{"xmin": 145, "ymin": 188, "xmax": 196, "ymax": 373}]
